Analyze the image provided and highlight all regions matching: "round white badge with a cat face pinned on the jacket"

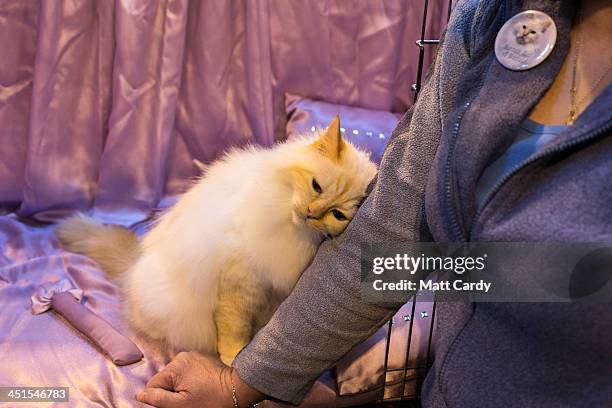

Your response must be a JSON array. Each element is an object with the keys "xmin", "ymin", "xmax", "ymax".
[{"xmin": 495, "ymin": 10, "xmax": 557, "ymax": 71}]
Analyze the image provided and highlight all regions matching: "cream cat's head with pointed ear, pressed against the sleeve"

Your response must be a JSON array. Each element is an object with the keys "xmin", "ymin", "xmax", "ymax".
[{"xmin": 291, "ymin": 117, "xmax": 376, "ymax": 237}]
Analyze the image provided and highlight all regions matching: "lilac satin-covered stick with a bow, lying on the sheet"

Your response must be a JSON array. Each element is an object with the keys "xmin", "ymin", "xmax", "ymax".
[{"xmin": 32, "ymin": 279, "xmax": 143, "ymax": 366}]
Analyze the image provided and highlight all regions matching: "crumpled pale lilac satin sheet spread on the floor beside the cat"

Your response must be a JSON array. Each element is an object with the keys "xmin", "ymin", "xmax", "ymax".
[{"xmin": 0, "ymin": 216, "xmax": 170, "ymax": 407}]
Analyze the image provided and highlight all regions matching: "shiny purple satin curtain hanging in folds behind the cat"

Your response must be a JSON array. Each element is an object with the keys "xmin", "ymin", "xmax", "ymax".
[{"xmin": 0, "ymin": 0, "xmax": 447, "ymax": 223}]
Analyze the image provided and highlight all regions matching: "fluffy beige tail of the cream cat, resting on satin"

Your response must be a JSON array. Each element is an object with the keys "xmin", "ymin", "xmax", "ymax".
[{"xmin": 55, "ymin": 214, "xmax": 140, "ymax": 277}]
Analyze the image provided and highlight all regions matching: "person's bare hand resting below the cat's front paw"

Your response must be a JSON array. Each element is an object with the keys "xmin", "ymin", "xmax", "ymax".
[{"xmin": 136, "ymin": 352, "xmax": 263, "ymax": 408}]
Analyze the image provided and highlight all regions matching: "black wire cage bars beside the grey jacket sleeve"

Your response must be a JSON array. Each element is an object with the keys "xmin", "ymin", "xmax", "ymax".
[{"xmin": 378, "ymin": 0, "xmax": 453, "ymax": 407}]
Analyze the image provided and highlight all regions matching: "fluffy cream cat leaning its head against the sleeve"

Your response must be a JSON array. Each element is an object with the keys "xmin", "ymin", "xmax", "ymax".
[{"xmin": 57, "ymin": 117, "xmax": 376, "ymax": 364}]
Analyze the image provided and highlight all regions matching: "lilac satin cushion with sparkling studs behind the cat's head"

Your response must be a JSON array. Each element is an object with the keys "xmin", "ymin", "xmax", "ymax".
[{"xmin": 285, "ymin": 93, "xmax": 401, "ymax": 164}]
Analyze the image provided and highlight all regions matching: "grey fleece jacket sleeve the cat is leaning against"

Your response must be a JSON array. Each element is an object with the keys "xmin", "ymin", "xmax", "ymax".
[{"xmin": 234, "ymin": 1, "xmax": 476, "ymax": 404}]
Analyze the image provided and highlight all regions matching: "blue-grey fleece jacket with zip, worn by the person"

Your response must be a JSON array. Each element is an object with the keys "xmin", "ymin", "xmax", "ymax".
[{"xmin": 234, "ymin": 0, "xmax": 612, "ymax": 407}]
